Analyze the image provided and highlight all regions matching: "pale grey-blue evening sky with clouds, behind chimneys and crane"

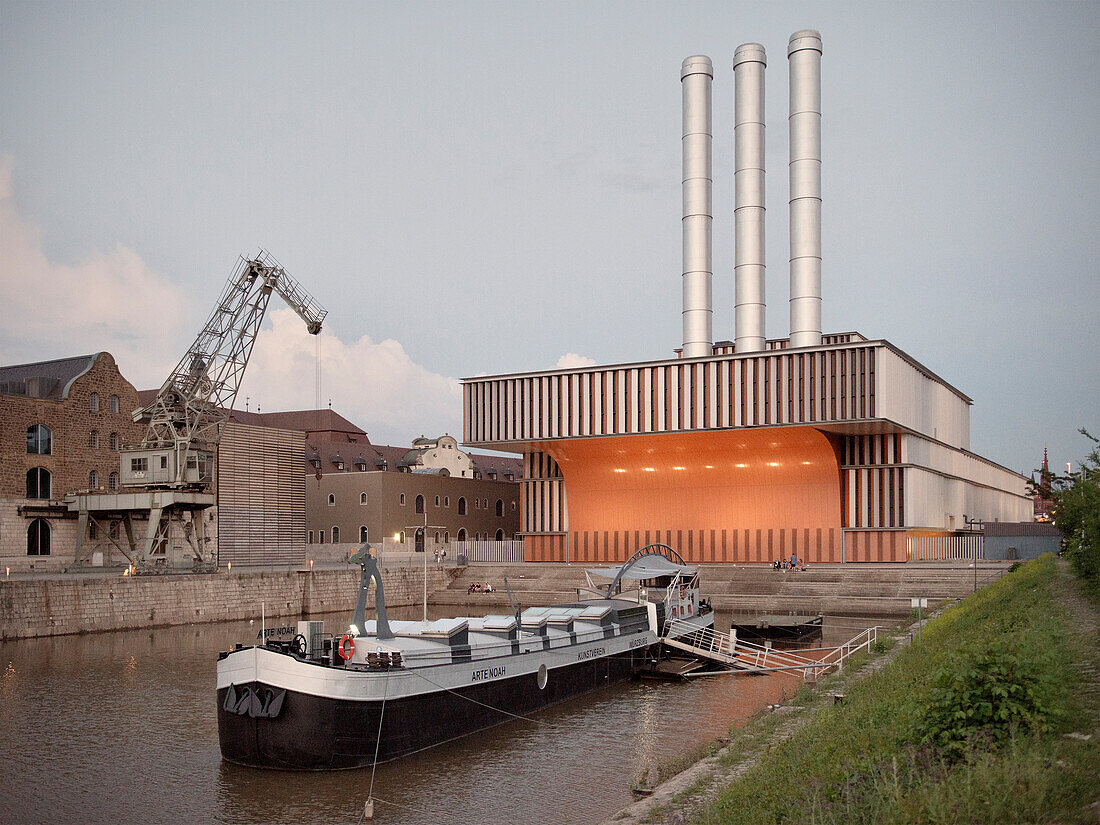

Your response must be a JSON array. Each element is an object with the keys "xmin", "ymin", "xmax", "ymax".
[{"xmin": 0, "ymin": 0, "xmax": 1100, "ymax": 474}]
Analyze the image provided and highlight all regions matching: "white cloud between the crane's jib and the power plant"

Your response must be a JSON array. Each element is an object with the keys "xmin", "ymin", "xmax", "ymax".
[{"xmin": 237, "ymin": 305, "xmax": 462, "ymax": 444}]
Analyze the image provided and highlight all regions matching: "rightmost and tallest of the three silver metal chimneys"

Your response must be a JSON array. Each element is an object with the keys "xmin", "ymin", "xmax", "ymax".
[{"xmin": 787, "ymin": 29, "xmax": 822, "ymax": 348}]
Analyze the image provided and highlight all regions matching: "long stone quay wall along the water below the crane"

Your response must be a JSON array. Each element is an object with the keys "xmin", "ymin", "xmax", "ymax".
[{"xmin": 0, "ymin": 568, "xmax": 450, "ymax": 639}]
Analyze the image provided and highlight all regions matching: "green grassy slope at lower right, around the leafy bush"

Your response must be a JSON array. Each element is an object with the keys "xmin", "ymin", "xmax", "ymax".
[{"xmin": 697, "ymin": 557, "xmax": 1100, "ymax": 823}]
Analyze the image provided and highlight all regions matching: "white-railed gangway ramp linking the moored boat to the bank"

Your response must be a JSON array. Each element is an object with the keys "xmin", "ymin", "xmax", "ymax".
[{"xmin": 661, "ymin": 619, "xmax": 878, "ymax": 679}]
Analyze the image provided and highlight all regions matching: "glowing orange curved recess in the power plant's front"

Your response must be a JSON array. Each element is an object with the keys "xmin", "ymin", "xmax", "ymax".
[{"xmin": 532, "ymin": 427, "xmax": 842, "ymax": 562}]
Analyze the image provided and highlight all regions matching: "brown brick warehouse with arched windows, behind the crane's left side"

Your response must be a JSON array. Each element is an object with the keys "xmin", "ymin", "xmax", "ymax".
[{"xmin": 0, "ymin": 352, "xmax": 143, "ymax": 570}]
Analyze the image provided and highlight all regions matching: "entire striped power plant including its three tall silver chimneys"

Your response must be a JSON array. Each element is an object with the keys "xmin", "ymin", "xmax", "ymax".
[{"xmin": 463, "ymin": 31, "xmax": 1033, "ymax": 562}]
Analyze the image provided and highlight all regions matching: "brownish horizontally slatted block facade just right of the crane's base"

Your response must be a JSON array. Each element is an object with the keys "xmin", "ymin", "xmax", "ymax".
[{"xmin": 218, "ymin": 422, "xmax": 306, "ymax": 564}]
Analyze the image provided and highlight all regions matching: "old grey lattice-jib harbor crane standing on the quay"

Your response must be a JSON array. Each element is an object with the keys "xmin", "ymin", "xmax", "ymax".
[{"xmin": 67, "ymin": 250, "xmax": 328, "ymax": 572}]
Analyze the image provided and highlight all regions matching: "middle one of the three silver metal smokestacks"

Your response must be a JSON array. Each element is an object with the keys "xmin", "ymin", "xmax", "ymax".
[{"xmin": 734, "ymin": 43, "xmax": 768, "ymax": 352}]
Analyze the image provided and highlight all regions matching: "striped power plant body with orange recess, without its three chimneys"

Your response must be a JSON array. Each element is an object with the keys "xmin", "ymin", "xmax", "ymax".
[{"xmin": 463, "ymin": 333, "xmax": 1030, "ymax": 562}]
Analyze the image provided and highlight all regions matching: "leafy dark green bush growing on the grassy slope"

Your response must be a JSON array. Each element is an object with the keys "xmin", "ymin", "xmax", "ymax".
[{"xmin": 914, "ymin": 648, "xmax": 1056, "ymax": 761}]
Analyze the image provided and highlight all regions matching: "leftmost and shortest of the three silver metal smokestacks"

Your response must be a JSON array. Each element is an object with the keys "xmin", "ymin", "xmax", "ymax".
[{"xmin": 680, "ymin": 55, "xmax": 714, "ymax": 358}]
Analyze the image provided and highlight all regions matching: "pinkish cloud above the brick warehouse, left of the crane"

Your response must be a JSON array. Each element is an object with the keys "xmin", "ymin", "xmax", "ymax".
[{"xmin": 0, "ymin": 155, "xmax": 190, "ymax": 389}]
